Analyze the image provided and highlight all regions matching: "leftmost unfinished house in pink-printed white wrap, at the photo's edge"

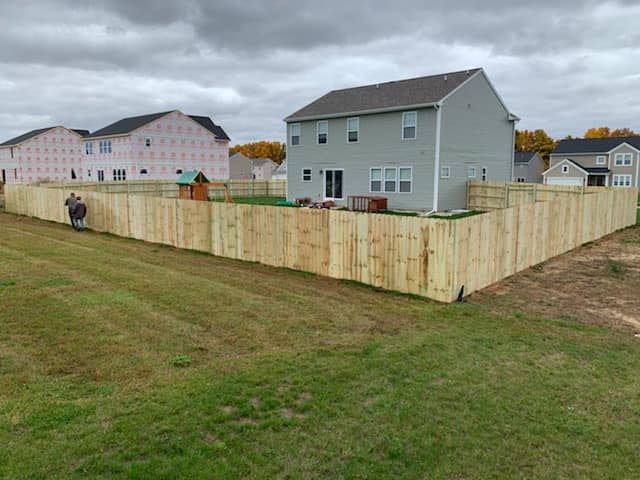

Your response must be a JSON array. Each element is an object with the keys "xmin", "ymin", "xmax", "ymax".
[{"xmin": 0, "ymin": 126, "xmax": 89, "ymax": 183}]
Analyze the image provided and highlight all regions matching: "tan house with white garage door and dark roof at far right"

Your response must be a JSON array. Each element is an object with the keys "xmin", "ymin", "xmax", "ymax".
[{"xmin": 543, "ymin": 137, "xmax": 640, "ymax": 187}]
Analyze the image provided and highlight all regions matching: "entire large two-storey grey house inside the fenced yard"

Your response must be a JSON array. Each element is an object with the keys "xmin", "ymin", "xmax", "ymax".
[{"xmin": 285, "ymin": 69, "xmax": 518, "ymax": 210}]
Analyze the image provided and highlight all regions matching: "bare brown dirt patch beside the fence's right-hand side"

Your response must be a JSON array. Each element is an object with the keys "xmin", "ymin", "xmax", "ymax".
[{"xmin": 469, "ymin": 226, "xmax": 640, "ymax": 333}]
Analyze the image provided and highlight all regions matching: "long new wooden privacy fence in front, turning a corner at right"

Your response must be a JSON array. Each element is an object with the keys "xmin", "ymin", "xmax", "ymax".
[{"xmin": 6, "ymin": 185, "xmax": 637, "ymax": 302}]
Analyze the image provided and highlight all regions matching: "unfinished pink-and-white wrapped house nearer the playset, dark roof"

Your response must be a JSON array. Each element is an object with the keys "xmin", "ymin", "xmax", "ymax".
[{"xmin": 83, "ymin": 110, "xmax": 229, "ymax": 182}]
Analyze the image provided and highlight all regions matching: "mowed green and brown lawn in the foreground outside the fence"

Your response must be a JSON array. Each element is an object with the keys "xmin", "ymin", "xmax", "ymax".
[{"xmin": 0, "ymin": 215, "xmax": 640, "ymax": 479}]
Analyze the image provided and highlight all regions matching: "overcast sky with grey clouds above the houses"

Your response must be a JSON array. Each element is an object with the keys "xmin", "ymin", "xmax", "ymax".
[{"xmin": 0, "ymin": 0, "xmax": 640, "ymax": 143}]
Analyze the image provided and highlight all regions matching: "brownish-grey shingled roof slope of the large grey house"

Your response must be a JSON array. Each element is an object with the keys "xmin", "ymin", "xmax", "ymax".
[{"xmin": 285, "ymin": 68, "xmax": 482, "ymax": 121}]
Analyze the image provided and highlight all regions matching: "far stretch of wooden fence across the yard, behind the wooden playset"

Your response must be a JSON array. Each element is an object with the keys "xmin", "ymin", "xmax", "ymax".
[{"xmin": 41, "ymin": 180, "xmax": 287, "ymax": 198}]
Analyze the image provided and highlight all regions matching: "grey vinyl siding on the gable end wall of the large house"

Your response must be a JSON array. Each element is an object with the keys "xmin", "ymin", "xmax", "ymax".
[{"xmin": 438, "ymin": 73, "xmax": 514, "ymax": 210}]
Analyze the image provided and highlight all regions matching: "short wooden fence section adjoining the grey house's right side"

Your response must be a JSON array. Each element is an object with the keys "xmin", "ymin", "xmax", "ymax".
[{"xmin": 467, "ymin": 180, "xmax": 607, "ymax": 210}]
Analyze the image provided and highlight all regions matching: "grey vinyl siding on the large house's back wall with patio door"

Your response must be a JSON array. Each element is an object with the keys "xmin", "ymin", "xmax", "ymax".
[{"xmin": 287, "ymin": 108, "xmax": 435, "ymax": 210}]
